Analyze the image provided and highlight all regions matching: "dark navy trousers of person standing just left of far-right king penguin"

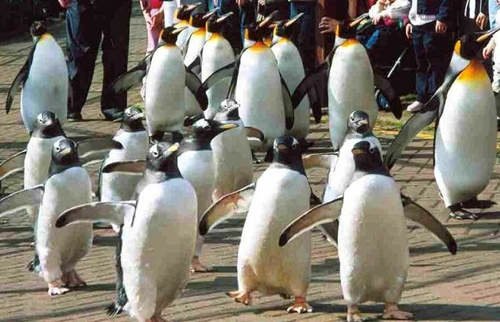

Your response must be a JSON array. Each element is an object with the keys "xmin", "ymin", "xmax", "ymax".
[{"xmin": 412, "ymin": 22, "xmax": 453, "ymax": 103}]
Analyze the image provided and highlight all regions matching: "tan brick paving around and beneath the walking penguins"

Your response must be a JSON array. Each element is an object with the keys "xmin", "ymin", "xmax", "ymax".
[{"xmin": 0, "ymin": 5, "xmax": 500, "ymax": 321}]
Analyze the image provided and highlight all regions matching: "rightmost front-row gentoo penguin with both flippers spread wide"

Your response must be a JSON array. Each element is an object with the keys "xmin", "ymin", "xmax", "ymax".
[{"xmin": 276, "ymin": 141, "xmax": 457, "ymax": 322}]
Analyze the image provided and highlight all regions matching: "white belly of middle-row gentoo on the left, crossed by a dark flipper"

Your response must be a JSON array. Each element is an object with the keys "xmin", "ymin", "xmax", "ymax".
[{"xmin": 100, "ymin": 130, "xmax": 149, "ymax": 201}]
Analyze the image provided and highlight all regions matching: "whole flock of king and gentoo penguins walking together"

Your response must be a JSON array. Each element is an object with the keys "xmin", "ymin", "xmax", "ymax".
[{"xmin": 0, "ymin": 10, "xmax": 498, "ymax": 322}]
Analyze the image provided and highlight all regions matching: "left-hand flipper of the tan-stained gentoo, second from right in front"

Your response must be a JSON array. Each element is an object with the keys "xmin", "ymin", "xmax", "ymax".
[{"xmin": 199, "ymin": 183, "xmax": 255, "ymax": 236}]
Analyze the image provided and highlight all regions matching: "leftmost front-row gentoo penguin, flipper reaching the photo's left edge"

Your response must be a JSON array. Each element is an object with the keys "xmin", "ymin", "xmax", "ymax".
[{"xmin": 0, "ymin": 138, "xmax": 92, "ymax": 296}]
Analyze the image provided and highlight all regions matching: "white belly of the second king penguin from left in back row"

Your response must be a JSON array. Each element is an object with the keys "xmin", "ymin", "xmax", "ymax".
[{"xmin": 145, "ymin": 45, "xmax": 186, "ymax": 134}]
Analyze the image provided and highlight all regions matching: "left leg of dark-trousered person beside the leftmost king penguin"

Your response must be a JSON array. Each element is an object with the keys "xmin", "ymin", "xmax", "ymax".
[{"xmin": 66, "ymin": 1, "xmax": 101, "ymax": 120}]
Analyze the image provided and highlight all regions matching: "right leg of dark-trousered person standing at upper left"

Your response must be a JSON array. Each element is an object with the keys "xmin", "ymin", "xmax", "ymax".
[{"xmin": 101, "ymin": 0, "xmax": 132, "ymax": 119}]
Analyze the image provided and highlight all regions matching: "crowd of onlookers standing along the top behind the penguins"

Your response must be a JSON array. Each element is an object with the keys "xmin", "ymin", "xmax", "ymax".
[{"xmin": 54, "ymin": 0, "xmax": 500, "ymax": 121}]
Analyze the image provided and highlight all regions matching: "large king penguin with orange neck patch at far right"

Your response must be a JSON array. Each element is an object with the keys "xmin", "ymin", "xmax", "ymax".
[{"xmin": 385, "ymin": 29, "xmax": 497, "ymax": 219}]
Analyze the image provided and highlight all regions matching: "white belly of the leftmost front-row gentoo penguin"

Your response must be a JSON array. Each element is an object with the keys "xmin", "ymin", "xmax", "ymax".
[{"xmin": 35, "ymin": 167, "xmax": 92, "ymax": 283}]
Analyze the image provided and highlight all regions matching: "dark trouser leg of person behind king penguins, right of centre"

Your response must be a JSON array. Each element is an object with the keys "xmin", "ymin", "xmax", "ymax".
[{"xmin": 290, "ymin": 1, "xmax": 316, "ymax": 72}]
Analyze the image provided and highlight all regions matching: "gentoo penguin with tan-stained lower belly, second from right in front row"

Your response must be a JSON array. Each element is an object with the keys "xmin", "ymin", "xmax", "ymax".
[{"xmin": 200, "ymin": 136, "xmax": 312, "ymax": 313}]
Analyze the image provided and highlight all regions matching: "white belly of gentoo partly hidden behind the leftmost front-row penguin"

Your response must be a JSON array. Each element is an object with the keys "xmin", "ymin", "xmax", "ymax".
[{"xmin": 24, "ymin": 136, "xmax": 63, "ymax": 189}]
